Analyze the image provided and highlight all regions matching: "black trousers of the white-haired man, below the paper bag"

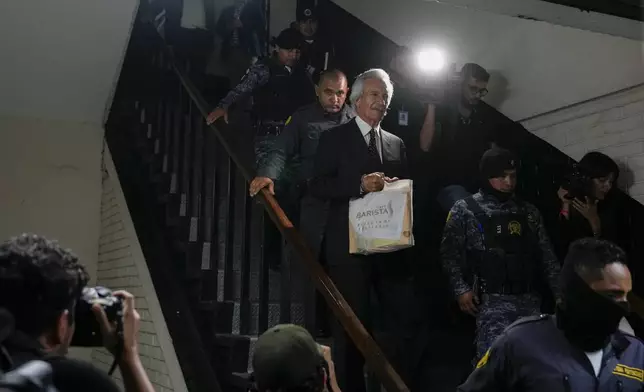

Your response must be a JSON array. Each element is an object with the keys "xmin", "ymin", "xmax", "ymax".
[{"xmin": 328, "ymin": 254, "xmax": 414, "ymax": 392}]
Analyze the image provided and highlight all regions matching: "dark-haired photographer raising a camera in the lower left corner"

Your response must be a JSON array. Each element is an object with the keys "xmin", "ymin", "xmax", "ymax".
[{"xmin": 0, "ymin": 234, "xmax": 154, "ymax": 392}]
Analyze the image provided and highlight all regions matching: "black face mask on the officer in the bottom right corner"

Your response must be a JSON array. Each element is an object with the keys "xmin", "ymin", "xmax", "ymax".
[{"xmin": 557, "ymin": 273, "xmax": 629, "ymax": 352}]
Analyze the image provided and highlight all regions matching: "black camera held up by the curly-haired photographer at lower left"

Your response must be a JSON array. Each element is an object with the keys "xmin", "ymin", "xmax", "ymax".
[{"xmin": 71, "ymin": 286, "xmax": 123, "ymax": 347}]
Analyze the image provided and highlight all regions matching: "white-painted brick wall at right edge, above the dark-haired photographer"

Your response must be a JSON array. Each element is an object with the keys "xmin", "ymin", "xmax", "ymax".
[{"xmin": 522, "ymin": 85, "xmax": 644, "ymax": 203}]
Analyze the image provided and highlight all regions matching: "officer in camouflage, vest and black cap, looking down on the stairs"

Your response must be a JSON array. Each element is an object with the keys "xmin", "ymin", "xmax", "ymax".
[{"xmin": 441, "ymin": 148, "xmax": 559, "ymax": 357}]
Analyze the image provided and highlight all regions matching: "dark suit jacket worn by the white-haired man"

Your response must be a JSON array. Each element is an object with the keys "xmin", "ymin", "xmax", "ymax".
[{"xmin": 309, "ymin": 120, "xmax": 408, "ymax": 264}]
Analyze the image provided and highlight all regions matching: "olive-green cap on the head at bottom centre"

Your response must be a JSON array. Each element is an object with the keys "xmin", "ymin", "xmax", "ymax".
[{"xmin": 253, "ymin": 324, "xmax": 324, "ymax": 390}]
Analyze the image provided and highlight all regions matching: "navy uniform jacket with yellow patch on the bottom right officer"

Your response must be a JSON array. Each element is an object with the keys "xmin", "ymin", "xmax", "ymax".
[{"xmin": 458, "ymin": 315, "xmax": 644, "ymax": 392}]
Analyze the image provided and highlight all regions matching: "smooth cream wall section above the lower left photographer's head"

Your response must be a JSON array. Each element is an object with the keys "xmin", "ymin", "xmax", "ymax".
[{"xmin": 0, "ymin": 116, "xmax": 103, "ymax": 359}]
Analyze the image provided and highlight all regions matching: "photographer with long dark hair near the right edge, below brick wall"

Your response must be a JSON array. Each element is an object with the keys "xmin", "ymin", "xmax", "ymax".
[{"xmin": 555, "ymin": 152, "xmax": 623, "ymax": 259}]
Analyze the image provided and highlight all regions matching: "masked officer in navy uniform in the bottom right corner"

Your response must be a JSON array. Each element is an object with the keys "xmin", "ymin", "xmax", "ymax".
[{"xmin": 458, "ymin": 238, "xmax": 644, "ymax": 392}]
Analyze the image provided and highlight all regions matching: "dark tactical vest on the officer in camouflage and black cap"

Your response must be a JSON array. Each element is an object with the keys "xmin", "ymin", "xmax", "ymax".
[{"xmin": 465, "ymin": 197, "xmax": 541, "ymax": 294}]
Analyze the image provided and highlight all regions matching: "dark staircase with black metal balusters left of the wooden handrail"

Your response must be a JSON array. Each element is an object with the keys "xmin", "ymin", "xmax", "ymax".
[{"xmin": 106, "ymin": 24, "xmax": 290, "ymax": 391}]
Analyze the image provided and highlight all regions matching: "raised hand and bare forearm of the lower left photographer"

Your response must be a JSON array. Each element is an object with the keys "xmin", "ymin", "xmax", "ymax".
[{"xmin": 92, "ymin": 291, "xmax": 154, "ymax": 392}]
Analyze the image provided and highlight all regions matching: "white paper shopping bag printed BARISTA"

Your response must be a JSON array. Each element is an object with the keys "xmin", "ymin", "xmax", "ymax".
[{"xmin": 349, "ymin": 180, "xmax": 414, "ymax": 255}]
